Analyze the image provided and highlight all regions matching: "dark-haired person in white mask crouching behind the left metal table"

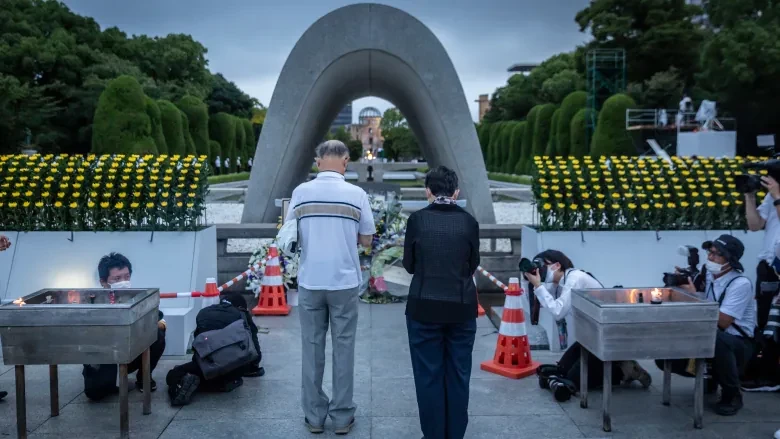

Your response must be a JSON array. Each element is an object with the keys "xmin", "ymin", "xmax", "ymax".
[{"xmin": 82, "ymin": 253, "xmax": 166, "ymax": 401}]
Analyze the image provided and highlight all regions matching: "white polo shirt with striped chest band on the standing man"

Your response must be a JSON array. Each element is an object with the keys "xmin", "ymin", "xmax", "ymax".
[{"xmin": 285, "ymin": 171, "xmax": 376, "ymax": 291}]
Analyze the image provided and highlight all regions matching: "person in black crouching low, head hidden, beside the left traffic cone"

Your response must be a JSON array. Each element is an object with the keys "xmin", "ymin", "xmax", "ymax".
[{"xmin": 165, "ymin": 293, "xmax": 265, "ymax": 407}]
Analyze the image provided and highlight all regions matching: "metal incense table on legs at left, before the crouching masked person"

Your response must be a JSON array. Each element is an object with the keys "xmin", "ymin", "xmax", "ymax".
[{"xmin": 0, "ymin": 289, "xmax": 160, "ymax": 439}]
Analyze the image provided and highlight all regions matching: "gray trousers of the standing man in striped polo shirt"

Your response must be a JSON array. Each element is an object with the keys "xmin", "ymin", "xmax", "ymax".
[{"xmin": 298, "ymin": 287, "xmax": 358, "ymax": 428}]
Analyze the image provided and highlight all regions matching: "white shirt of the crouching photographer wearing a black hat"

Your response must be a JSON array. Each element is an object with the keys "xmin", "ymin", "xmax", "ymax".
[{"xmin": 704, "ymin": 270, "xmax": 757, "ymax": 337}]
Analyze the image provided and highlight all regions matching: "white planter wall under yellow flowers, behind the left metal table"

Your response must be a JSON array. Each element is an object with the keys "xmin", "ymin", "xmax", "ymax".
[{"xmin": 0, "ymin": 227, "xmax": 217, "ymax": 355}]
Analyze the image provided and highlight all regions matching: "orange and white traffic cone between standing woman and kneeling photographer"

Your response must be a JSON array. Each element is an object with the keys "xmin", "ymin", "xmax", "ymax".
[{"xmin": 480, "ymin": 277, "xmax": 539, "ymax": 379}]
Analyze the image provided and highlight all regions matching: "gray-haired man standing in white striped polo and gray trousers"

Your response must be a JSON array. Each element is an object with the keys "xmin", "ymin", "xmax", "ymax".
[{"xmin": 285, "ymin": 140, "xmax": 376, "ymax": 434}]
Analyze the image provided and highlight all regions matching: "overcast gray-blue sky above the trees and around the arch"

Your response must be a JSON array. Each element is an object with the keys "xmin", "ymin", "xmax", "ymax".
[{"xmin": 64, "ymin": 0, "xmax": 588, "ymax": 120}]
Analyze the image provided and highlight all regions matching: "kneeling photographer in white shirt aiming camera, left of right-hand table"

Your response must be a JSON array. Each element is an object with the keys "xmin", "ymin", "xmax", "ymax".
[{"xmin": 519, "ymin": 250, "xmax": 652, "ymax": 401}]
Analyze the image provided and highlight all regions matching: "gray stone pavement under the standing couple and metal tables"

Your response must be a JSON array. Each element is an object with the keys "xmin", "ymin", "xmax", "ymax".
[{"xmin": 0, "ymin": 304, "xmax": 780, "ymax": 439}]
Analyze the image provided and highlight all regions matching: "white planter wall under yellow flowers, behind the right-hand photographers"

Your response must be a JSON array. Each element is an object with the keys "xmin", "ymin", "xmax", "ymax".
[{"xmin": 521, "ymin": 227, "xmax": 764, "ymax": 351}]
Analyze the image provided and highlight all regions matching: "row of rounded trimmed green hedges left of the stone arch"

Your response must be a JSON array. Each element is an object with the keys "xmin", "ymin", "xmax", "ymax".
[{"xmin": 92, "ymin": 76, "xmax": 256, "ymax": 173}]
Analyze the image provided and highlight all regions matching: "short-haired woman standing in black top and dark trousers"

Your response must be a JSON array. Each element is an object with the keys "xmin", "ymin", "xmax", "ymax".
[{"xmin": 404, "ymin": 166, "xmax": 479, "ymax": 439}]
